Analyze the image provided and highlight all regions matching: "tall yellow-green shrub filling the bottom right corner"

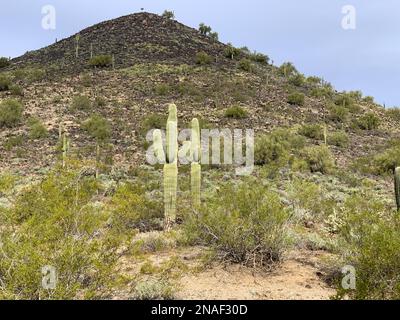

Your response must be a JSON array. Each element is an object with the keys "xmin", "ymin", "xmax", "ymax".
[{"xmin": 338, "ymin": 194, "xmax": 400, "ymax": 300}]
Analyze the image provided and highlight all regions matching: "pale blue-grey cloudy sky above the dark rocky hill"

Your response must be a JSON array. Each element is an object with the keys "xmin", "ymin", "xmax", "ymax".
[{"xmin": 0, "ymin": 0, "xmax": 400, "ymax": 106}]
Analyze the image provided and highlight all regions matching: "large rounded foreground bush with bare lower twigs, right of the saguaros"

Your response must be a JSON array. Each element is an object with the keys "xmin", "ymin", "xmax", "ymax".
[{"xmin": 184, "ymin": 182, "xmax": 289, "ymax": 268}]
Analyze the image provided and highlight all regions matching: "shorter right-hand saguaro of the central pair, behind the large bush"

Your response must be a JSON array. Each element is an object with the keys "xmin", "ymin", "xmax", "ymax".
[{"xmin": 190, "ymin": 119, "xmax": 201, "ymax": 208}]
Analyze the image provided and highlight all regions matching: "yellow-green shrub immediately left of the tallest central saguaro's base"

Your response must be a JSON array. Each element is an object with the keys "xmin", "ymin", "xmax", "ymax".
[{"xmin": 109, "ymin": 183, "xmax": 164, "ymax": 234}]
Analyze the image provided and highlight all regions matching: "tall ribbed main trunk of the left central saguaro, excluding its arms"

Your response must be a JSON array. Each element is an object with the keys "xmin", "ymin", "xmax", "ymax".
[{"xmin": 164, "ymin": 104, "xmax": 178, "ymax": 231}]
